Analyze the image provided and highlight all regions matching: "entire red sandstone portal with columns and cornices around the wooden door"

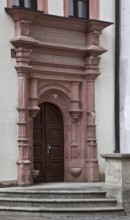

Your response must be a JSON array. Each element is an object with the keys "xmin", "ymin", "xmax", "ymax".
[{"xmin": 7, "ymin": 8, "xmax": 111, "ymax": 185}]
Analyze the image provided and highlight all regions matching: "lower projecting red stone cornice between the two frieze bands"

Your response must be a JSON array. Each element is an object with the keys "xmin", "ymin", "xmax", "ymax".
[{"xmin": 11, "ymin": 39, "xmax": 107, "ymax": 57}]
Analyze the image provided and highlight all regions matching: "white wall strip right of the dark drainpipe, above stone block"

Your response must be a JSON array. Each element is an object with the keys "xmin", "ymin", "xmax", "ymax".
[{"xmin": 120, "ymin": 0, "xmax": 130, "ymax": 154}]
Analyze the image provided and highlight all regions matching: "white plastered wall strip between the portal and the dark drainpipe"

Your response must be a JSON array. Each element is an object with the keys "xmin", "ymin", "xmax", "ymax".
[{"xmin": 95, "ymin": 0, "xmax": 115, "ymax": 178}]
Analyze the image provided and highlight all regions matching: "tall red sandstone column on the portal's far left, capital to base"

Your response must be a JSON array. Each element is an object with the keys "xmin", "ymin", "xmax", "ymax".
[{"xmin": 15, "ymin": 48, "xmax": 32, "ymax": 185}]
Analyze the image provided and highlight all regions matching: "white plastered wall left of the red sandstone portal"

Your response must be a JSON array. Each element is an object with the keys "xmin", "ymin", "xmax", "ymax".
[{"xmin": 0, "ymin": 0, "xmax": 18, "ymax": 183}]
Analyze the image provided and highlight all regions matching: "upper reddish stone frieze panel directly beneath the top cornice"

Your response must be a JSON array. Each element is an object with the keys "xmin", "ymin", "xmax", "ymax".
[{"xmin": 30, "ymin": 25, "xmax": 86, "ymax": 45}]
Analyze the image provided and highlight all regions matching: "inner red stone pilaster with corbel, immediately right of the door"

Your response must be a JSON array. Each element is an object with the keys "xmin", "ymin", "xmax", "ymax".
[{"xmin": 69, "ymin": 82, "xmax": 82, "ymax": 177}]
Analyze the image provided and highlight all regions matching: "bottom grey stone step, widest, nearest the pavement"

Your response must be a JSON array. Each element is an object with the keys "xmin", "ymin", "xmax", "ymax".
[{"xmin": 0, "ymin": 206, "xmax": 124, "ymax": 217}]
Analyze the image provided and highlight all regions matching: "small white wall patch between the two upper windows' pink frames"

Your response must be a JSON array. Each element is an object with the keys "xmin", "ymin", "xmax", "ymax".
[{"xmin": 48, "ymin": 0, "xmax": 64, "ymax": 16}]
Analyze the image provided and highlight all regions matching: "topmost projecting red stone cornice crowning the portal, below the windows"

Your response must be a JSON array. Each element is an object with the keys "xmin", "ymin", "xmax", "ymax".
[{"xmin": 5, "ymin": 8, "xmax": 112, "ymax": 33}]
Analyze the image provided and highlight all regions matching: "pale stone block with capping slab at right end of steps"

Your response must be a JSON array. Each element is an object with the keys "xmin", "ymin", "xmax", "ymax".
[{"xmin": 101, "ymin": 153, "xmax": 130, "ymax": 213}]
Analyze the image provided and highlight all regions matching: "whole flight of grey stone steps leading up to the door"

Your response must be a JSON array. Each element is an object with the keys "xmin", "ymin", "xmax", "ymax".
[{"xmin": 0, "ymin": 183, "xmax": 125, "ymax": 219}]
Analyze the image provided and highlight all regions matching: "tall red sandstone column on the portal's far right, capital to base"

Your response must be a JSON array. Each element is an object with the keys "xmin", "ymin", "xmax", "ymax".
[{"xmin": 86, "ymin": 56, "xmax": 100, "ymax": 182}]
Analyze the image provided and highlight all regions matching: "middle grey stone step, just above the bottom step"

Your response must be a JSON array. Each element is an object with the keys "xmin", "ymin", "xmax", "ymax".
[{"xmin": 0, "ymin": 198, "xmax": 117, "ymax": 209}]
